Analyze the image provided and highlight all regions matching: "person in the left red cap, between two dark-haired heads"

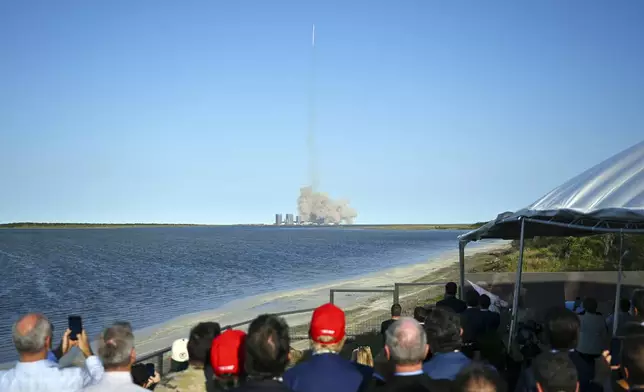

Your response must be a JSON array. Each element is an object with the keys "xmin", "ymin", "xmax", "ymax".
[{"xmin": 210, "ymin": 329, "xmax": 246, "ymax": 391}]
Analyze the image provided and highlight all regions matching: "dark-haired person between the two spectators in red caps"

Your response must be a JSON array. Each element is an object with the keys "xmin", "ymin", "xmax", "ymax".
[{"xmin": 235, "ymin": 314, "xmax": 291, "ymax": 392}]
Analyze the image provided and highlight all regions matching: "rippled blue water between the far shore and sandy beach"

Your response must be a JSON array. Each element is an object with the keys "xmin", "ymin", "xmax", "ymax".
[{"xmin": 0, "ymin": 227, "xmax": 460, "ymax": 363}]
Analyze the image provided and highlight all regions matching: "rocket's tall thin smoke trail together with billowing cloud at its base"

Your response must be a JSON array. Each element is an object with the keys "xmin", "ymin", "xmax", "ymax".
[{"xmin": 297, "ymin": 25, "xmax": 358, "ymax": 224}]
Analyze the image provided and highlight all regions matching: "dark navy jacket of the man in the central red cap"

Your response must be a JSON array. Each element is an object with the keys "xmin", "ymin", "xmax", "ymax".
[{"xmin": 284, "ymin": 354, "xmax": 373, "ymax": 392}]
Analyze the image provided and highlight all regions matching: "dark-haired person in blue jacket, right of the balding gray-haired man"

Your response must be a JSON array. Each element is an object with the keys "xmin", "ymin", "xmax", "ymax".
[{"xmin": 423, "ymin": 307, "xmax": 472, "ymax": 380}]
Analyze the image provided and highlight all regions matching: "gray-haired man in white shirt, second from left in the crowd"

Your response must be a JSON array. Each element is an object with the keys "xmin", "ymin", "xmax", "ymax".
[{"xmin": 85, "ymin": 324, "xmax": 147, "ymax": 392}]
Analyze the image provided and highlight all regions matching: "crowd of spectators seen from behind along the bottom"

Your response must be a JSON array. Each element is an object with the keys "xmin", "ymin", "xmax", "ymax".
[{"xmin": 0, "ymin": 283, "xmax": 644, "ymax": 392}]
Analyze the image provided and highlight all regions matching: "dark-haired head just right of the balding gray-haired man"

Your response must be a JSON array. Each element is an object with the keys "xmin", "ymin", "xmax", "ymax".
[{"xmin": 425, "ymin": 307, "xmax": 463, "ymax": 354}]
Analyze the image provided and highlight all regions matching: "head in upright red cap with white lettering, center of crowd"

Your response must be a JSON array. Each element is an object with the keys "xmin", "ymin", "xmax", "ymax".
[{"xmin": 309, "ymin": 303, "xmax": 346, "ymax": 353}]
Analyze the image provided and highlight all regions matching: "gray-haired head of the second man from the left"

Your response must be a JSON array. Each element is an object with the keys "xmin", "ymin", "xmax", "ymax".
[{"xmin": 98, "ymin": 323, "xmax": 134, "ymax": 369}]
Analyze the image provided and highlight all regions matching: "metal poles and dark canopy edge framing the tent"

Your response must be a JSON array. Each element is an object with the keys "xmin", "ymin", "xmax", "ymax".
[{"xmin": 458, "ymin": 216, "xmax": 644, "ymax": 350}]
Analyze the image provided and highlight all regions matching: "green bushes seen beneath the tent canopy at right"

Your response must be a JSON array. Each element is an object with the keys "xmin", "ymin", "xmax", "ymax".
[{"xmin": 471, "ymin": 234, "xmax": 644, "ymax": 272}]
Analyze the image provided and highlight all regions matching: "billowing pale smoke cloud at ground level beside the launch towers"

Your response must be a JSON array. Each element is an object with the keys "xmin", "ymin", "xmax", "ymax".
[{"xmin": 297, "ymin": 186, "xmax": 358, "ymax": 224}]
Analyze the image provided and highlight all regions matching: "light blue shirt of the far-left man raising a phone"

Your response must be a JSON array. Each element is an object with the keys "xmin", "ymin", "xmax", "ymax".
[{"xmin": 0, "ymin": 356, "xmax": 104, "ymax": 392}]
